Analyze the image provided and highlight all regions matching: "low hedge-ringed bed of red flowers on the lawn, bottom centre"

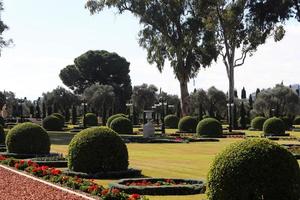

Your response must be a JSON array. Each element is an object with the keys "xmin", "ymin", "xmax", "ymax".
[{"xmin": 109, "ymin": 178, "xmax": 205, "ymax": 195}]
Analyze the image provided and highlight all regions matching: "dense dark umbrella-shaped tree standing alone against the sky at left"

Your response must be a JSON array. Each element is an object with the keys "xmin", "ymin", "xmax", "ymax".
[{"xmin": 59, "ymin": 50, "xmax": 132, "ymax": 111}]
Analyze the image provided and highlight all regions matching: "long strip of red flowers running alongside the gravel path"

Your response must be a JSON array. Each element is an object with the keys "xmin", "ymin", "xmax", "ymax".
[{"xmin": 0, "ymin": 155, "xmax": 146, "ymax": 200}]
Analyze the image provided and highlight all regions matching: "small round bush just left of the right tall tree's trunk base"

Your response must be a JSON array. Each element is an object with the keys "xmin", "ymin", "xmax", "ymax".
[{"xmin": 196, "ymin": 118, "xmax": 223, "ymax": 137}]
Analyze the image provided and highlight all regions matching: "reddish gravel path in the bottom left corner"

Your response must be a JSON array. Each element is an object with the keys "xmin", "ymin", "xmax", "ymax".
[{"xmin": 0, "ymin": 166, "xmax": 94, "ymax": 200}]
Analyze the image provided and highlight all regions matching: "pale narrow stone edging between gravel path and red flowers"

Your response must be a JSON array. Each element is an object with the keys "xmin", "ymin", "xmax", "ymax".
[{"xmin": 0, "ymin": 164, "xmax": 96, "ymax": 200}]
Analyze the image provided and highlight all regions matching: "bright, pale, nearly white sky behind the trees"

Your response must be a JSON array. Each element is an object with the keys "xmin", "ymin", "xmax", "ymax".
[{"xmin": 0, "ymin": 0, "xmax": 300, "ymax": 99}]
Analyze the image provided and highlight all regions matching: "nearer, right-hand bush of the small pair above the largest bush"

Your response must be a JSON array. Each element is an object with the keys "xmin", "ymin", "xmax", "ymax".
[{"xmin": 263, "ymin": 117, "xmax": 285, "ymax": 135}]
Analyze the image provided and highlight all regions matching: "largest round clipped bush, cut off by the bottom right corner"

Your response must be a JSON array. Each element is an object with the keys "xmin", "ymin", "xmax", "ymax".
[{"xmin": 207, "ymin": 139, "xmax": 300, "ymax": 200}]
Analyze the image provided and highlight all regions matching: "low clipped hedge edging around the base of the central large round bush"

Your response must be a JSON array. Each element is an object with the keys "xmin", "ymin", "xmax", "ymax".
[{"xmin": 63, "ymin": 168, "xmax": 142, "ymax": 179}]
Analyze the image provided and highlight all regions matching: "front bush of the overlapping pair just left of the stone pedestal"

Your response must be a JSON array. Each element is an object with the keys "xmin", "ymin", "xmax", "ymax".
[{"xmin": 110, "ymin": 117, "xmax": 133, "ymax": 134}]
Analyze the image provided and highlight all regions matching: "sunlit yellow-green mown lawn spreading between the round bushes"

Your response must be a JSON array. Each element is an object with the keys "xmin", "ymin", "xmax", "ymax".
[{"xmin": 49, "ymin": 130, "xmax": 300, "ymax": 200}]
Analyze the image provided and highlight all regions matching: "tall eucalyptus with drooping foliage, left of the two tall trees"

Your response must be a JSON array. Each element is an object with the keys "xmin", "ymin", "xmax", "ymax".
[{"xmin": 86, "ymin": 0, "xmax": 217, "ymax": 115}]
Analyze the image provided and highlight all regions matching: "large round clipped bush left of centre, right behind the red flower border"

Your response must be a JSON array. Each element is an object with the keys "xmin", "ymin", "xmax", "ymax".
[{"xmin": 68, "ymin": 126, "xmax": 128, "ymax": 173}]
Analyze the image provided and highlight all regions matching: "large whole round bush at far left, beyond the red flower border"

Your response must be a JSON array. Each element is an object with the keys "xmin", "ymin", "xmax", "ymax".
[{"xmin": 5, "ymin": 122, "xmax": 50, "ymax": 154}]
